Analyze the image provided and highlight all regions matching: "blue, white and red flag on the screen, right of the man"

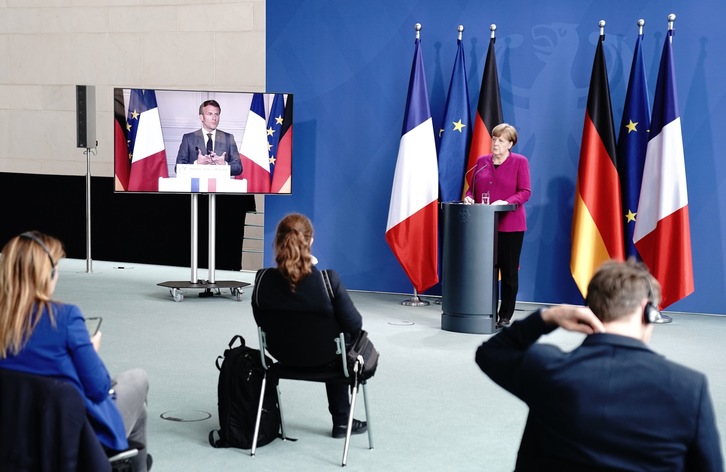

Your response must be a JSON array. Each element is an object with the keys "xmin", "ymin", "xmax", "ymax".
[{"xmin": 238, "ymin": 93, "xmax": 270, "ymax": 193}]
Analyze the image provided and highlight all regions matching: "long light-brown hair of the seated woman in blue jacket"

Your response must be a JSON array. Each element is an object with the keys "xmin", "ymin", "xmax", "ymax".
[{"xmin": 0, "ymin": 231, "xmax": 65, "ymax": 359}]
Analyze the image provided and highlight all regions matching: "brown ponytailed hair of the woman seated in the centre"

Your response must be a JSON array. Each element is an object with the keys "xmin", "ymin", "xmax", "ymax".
[{"xmin": 274, "ymin": 213, "xmax": 313, "ymax": 292}]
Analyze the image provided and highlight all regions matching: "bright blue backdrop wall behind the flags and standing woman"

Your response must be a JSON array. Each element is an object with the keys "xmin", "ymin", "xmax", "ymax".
[{"xmin": 265, "ymin": 0, "xmax": 726, "ymax": 314}]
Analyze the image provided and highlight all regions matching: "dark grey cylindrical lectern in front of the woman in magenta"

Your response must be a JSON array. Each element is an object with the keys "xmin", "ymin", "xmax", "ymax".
[{"xmin": 441, "ymin": 202, "xmax": 517, "ymax": 334}]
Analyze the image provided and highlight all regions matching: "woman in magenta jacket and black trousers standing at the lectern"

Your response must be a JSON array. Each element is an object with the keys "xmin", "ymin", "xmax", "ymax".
[{"xmin": 464, "ymin": 123, "xmax": 532, "ymax": 327}]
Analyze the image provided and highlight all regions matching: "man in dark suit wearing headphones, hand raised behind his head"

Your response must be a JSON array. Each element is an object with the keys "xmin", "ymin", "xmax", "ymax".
[{"xmin": 476, "ymin": 261, "xmax": 723, "ymax": 472}]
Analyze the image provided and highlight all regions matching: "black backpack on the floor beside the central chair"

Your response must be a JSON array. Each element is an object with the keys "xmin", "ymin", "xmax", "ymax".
[{"xmin": 209, "ymin": 335, "xmax": 280, "ymax": 449}]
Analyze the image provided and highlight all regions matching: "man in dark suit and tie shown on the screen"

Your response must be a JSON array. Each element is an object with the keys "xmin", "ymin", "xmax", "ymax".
[{"xmin": 176, "ymin": 100, "xmax": 242, "ymax": 175}]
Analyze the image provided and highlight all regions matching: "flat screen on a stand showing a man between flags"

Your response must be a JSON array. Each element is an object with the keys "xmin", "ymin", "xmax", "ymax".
[{"xmin": 114, "ymin": 88, "xmax": 293, "ymax": 194}]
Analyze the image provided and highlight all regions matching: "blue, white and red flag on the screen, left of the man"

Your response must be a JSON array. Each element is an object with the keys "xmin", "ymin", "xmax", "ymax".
[{"xmin": 126, "ymin": 89, "xmax": 169, "ymax": 192}]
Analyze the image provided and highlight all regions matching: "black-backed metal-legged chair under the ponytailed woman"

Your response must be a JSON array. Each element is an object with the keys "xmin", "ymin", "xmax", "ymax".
[{"xmin": 251, "ymin": 310, "xmax": 373, "ymax": 466}]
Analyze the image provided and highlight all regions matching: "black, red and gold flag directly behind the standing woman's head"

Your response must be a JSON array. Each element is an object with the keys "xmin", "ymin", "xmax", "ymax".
[{"xmin": 461, "ymin": 34, "xmax": 504, "ymax": 199}]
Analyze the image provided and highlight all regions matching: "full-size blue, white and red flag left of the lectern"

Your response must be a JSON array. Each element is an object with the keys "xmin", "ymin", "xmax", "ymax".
[{"xmin": 386, "ymin": 38, "xmax": 439, "ymax": 292}]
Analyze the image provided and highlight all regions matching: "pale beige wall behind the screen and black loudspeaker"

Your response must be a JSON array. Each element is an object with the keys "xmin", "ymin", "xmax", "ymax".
[{"xmin": 0, "ymin": 0, "xmax": 265, "ymax": 177}]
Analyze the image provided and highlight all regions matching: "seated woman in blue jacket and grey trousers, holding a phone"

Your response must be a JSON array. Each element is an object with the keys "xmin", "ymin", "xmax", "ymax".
[{"xmin": 0, "ymin": 231, "xmax": 151, "ymax": 472}]
